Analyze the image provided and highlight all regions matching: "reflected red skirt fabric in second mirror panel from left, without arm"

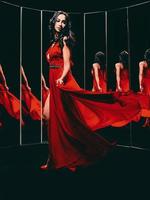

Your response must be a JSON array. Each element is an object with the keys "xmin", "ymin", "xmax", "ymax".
[{"xmin": 22, "ymin": 84, "xmax": 41, "ymax": 120}]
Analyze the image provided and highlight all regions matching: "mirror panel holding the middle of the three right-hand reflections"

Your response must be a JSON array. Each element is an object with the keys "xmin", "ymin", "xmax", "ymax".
[{"xmin": 107, "ymin": 8, "xmax": 131, "ymax": 146}]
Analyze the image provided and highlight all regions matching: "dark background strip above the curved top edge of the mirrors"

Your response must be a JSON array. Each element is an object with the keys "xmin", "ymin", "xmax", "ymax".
[{"xmin": 1, "ymin": 0, "xmax": 148, "ymax": 13}]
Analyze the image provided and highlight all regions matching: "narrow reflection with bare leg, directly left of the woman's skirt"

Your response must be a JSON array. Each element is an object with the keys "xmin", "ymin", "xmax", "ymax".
[{"xmin": 42, "ymin": 74, "xmax": 50, "ymax": 120}]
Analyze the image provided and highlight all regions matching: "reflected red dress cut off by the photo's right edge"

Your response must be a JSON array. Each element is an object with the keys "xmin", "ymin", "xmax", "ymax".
[{"xmin": 138, "ymin": 67, "xmax": 150, "ymax": 117}]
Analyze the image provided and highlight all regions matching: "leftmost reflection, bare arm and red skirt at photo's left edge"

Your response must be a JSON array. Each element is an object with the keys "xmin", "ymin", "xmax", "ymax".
[{"xmin": 0, "ymin": 64, "xmax": 20, "ymax": 123}]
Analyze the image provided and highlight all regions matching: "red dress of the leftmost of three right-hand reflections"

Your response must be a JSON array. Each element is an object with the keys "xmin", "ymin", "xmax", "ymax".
[{"xmin": 92, "ymin": 69, "xmax": 107, "ymax": 93}]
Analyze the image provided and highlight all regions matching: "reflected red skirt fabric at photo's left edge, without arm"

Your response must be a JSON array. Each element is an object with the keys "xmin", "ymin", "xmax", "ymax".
[{"xmin": 0, "ymin": 83, "xmax": 20, "ymax": 120}]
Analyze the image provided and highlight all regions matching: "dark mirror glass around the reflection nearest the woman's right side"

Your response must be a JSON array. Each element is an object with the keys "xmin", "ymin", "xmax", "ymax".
[{"xmin": 84, "ymin": 12, "xmax": 106, "ymax": 90}]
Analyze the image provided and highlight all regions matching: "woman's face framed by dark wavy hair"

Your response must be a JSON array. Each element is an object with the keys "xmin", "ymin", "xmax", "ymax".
[{"xmin": 54, "ymin": 14, "xmax": 66, "ymax": 32}]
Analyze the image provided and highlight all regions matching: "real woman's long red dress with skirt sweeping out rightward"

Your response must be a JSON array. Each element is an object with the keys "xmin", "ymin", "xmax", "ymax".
[{"xmin": 46, "ymin": 43, "xmax": 140, "ymax": 169}]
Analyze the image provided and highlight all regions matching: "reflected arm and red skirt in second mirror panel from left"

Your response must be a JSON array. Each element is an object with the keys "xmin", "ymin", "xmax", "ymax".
[{"xmin": 20, "ymin": 66, "xmax": 41, "ymax": 120}]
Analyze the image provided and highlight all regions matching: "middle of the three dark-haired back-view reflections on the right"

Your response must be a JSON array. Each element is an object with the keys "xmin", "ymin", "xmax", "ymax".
[{"xmin": 115, "ymin": 50, "xmax": 130, "ymax": 92}]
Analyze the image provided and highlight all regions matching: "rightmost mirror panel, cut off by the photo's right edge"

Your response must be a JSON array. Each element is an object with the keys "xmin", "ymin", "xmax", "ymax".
[{"xmin": 129, "ymin": 3, "xmax": 150, "ymax": 149}]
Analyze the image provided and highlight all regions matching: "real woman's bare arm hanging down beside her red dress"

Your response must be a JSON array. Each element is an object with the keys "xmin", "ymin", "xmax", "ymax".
[{"xmin": 56, "ymin": 38, "xmax": 71, "ymax": 84}]
